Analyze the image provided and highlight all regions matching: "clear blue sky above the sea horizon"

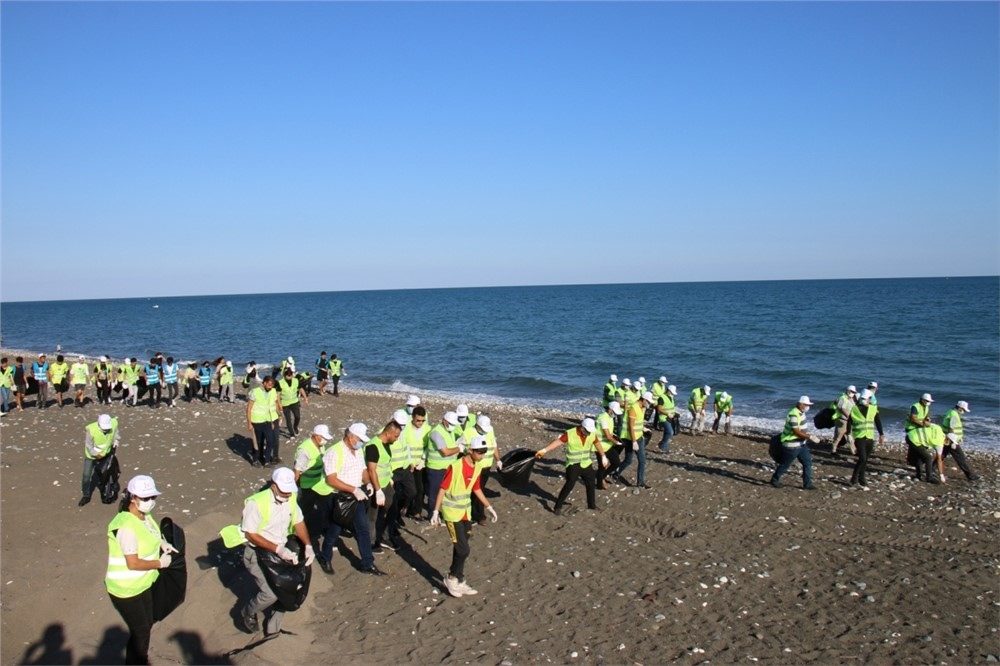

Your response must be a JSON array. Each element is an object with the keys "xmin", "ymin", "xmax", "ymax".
[{"xmin": 0, "ymin": 2, "xmax": 1000, "ymax": 301}]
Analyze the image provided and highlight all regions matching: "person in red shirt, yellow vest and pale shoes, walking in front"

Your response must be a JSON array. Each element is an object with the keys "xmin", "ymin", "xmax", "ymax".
[{"xmin": 431, "ymin": 437, "xmax": 497, "ymax": 597}]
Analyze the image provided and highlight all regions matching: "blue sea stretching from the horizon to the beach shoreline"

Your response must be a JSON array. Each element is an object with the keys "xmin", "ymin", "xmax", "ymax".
[{"xmin": 0, "ymin": 277, "xmax": 1000, "ymax": 451}]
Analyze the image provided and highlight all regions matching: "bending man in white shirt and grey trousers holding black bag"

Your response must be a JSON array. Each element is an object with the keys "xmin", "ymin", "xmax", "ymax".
[{"xmin": 240, "ymin": 467, "xmax": 316, "ymax": 636}]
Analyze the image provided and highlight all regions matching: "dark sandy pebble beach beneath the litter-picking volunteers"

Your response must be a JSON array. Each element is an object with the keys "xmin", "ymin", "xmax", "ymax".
[{"xmin": 0, "ymin": 353, "xmax": 1000, "ymax": 664}]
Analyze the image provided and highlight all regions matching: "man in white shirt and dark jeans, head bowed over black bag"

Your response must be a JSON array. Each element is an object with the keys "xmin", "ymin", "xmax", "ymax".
[{"xmin": 319, "ymin": 423, "xmax": 383, "ymax": 576}]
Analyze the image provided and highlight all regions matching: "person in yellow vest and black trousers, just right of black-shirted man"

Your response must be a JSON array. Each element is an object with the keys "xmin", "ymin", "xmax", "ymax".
[{"xmin": 389, "ymin": 402, "xmax": 431, "ymax": 527}]
